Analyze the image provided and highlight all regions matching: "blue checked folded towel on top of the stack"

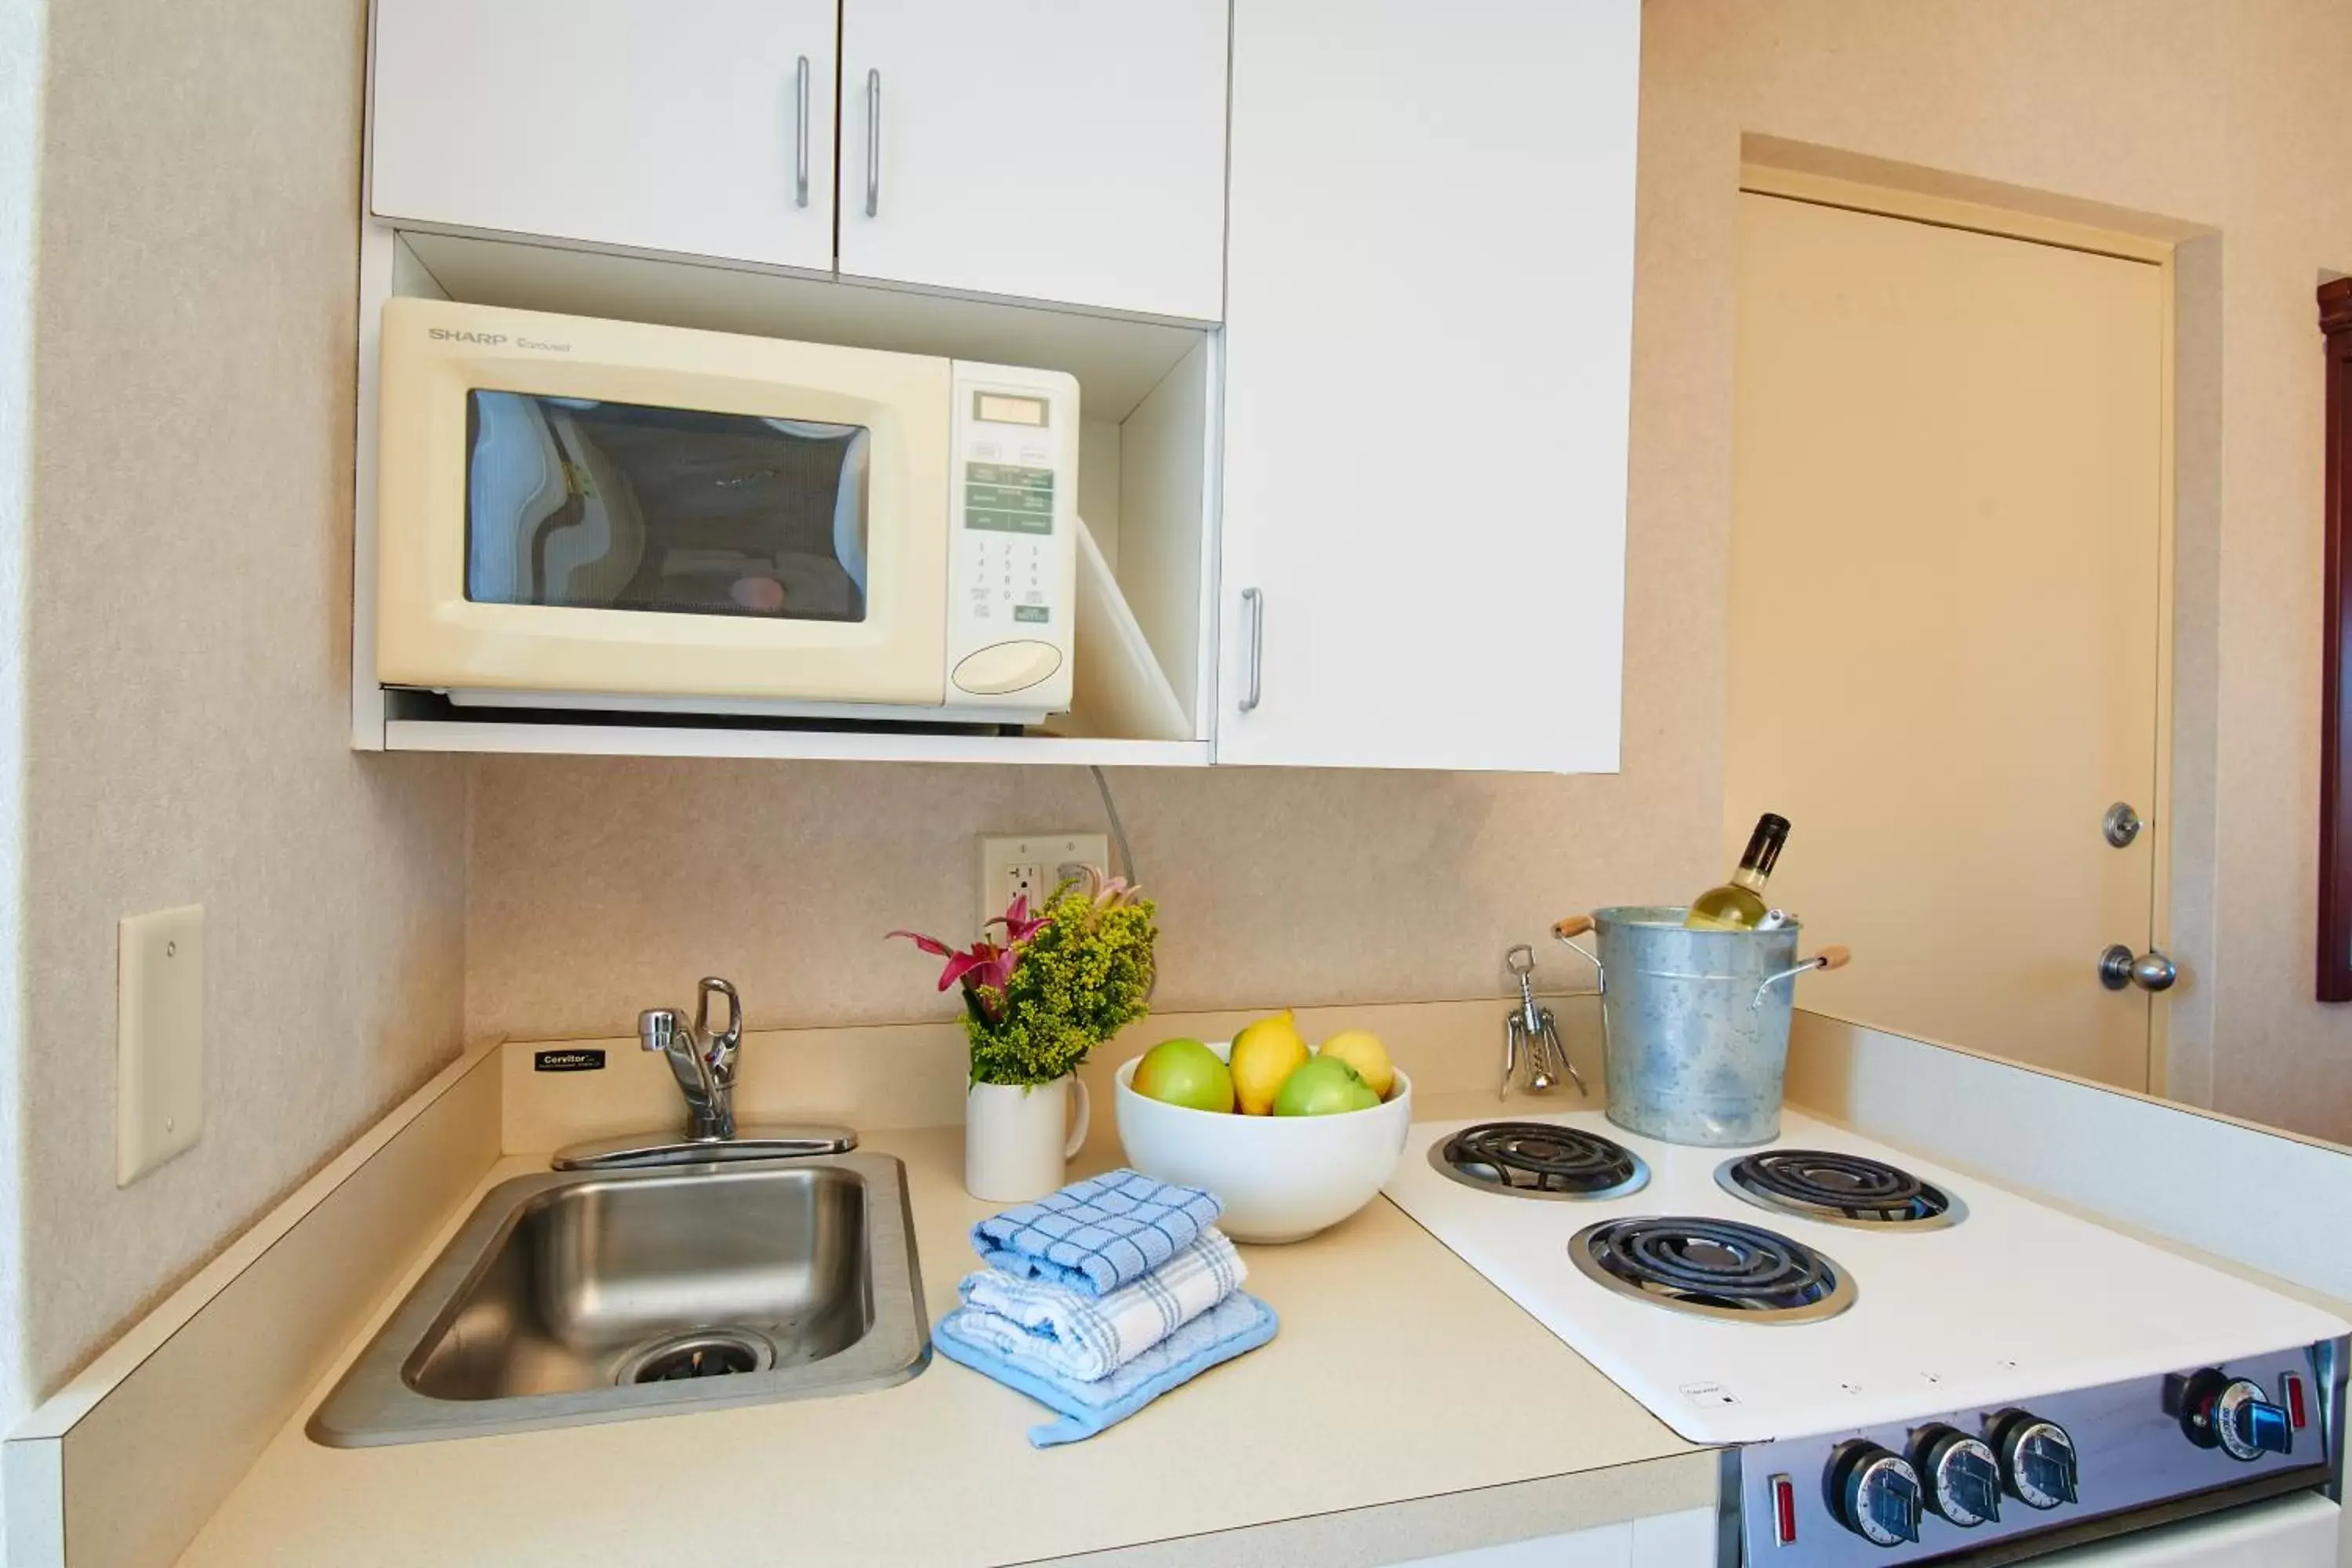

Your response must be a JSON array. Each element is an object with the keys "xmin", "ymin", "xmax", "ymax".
[{"xmin": 971, "ymin": 1171, "xmax": 1225, "ymax": 1295}]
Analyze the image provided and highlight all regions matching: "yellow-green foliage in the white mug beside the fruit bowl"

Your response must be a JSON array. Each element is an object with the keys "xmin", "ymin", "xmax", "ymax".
[{"xmin": 964, "ymin": 886, "xmax": 1160, "ymax": 1083}]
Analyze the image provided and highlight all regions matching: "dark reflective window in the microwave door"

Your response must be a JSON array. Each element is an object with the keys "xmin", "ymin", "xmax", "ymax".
[{"xmin": 466, "ymin": 390, "xmax": 873, "ymax": 621}]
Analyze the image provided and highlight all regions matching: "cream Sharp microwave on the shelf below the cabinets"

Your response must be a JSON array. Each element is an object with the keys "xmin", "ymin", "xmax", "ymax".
[{"xmin": 376, "ymin": 299, "xmax": 1077, "ymax": 724}]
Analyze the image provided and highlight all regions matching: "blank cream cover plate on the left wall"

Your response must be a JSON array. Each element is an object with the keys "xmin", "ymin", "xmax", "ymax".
[{"xmin": 115, "ymin": 905, "xmax": 205, "ymax": 1187}]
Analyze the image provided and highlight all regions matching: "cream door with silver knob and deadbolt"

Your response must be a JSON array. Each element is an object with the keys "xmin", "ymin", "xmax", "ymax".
[{"xmin": 1724, "ymin": 193, "xmax": 2169, "ymax": 1091}]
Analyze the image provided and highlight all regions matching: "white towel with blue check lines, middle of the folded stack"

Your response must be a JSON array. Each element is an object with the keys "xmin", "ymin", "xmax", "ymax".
[{"xmin": 957, "ymin": 1227, "xmax": 1249, "ymax": 1382}]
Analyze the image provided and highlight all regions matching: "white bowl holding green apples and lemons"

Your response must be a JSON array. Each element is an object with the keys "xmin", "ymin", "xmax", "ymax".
[{"xmin": 1117, "ymin": 1041, "xmax": 1414, "ymax": 1241}]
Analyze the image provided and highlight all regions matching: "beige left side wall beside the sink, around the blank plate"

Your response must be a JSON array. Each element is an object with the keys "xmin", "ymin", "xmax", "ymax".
[{"xmin": 12, "ymin": 0, "xmax": 463, "ymax": 1392}]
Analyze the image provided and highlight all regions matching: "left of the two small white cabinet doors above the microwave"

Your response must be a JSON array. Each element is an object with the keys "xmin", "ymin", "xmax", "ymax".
[{"xmin": 369, "ymin": 0, "xmax": 837, "ymax": 270}]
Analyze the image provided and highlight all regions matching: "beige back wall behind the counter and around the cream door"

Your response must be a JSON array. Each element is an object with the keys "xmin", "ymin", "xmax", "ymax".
[{"xmin": 466, "ymin": 0, "xmax": 2352, "ymax": 1138}]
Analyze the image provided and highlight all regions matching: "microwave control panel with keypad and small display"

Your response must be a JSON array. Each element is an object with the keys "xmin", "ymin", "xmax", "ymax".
[{"xmin": 948, "ymin": 362, "xmax": 1077, "ymax": 717}]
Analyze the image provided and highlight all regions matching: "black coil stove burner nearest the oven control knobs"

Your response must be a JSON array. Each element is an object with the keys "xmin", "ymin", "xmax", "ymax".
[{"xmin": 1569, "ymin": 1215, "xmax": 1853, "ymax": 1323}]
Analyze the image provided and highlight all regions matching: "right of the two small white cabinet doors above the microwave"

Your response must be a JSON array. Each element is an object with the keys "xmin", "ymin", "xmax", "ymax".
[{"xmin": 840, "ymin": 0, "xmax": 1225, "ymax": 320}]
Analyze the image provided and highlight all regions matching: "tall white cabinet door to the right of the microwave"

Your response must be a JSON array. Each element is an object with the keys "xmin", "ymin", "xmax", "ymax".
[{"xmin": 1216, "ymin": 0, "xmax": 1639, "ymax": 771}]
